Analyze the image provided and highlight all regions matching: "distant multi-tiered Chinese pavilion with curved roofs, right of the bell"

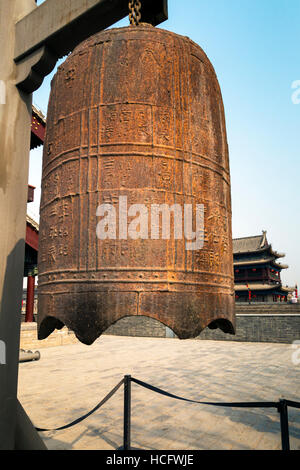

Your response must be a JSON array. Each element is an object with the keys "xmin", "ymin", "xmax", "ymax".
[{"xmin": 233, "ymin": 231, "xmax": 293, "ymax": 302}]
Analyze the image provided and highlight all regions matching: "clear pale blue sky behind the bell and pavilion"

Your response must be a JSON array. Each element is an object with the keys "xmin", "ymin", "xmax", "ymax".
[{"xmin": 28, "ymin": 0, "xmax": 300, "ymax": 285}]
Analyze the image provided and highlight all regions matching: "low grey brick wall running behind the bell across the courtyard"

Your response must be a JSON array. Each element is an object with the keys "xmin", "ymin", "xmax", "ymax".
[{"xmin": 20, "ymin": 304, "xmax": 300, "ymax": 350}]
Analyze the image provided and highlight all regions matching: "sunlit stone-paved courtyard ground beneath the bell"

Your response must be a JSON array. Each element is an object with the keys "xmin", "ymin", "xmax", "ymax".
[{"xmin": 18, "ymin": 336, "xmax": 300, "ymax": 450}]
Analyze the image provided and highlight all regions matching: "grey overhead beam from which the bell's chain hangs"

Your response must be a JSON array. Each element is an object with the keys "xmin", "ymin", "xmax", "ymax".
[{"xmin": 15, "ymin": 0, "xmax": 168, "ymax": 93}]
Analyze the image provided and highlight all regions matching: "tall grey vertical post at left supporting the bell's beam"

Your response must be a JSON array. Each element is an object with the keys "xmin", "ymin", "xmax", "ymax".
[{"xmin": 0, "ymin": 0, "xmax": 36, "ymax": 450}]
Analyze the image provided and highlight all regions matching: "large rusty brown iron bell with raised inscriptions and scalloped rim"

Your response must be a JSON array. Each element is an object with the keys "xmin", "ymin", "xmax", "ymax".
[{"xmin": 38, "ymin": 24, "xmax": 235, "ymax": 344}]
